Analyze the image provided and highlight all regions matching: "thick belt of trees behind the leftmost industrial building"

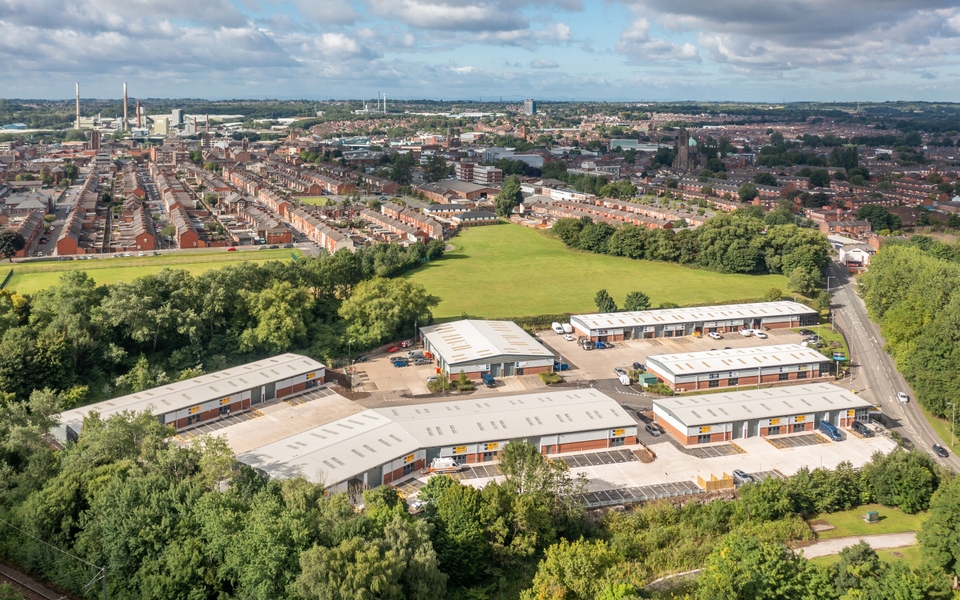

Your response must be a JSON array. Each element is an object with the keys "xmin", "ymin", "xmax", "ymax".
[{"xmin": 0, "ymin": 241, "xmax": 443, "ymax": 403}]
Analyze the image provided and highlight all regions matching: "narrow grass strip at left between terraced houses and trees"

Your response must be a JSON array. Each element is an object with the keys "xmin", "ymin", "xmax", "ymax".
[{"xmin": 4, "ymin": 249, "xmax": 302, "ymax": 294}]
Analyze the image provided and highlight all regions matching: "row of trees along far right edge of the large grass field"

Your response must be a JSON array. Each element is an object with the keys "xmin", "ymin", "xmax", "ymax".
[{"xmin": 553, "ymin": 214, "xmax": 830, "ymax": 292}]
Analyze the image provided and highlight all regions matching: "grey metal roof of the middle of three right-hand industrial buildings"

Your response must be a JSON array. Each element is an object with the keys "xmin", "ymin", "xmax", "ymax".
[{"xmin": 647, "ymin": 344, "xmax": 830, "ymax": 375}]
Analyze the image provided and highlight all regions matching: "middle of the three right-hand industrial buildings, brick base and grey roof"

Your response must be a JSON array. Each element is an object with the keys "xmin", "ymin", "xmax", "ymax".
[{"xmin": 647, "ymin": 344, "xmax": 830, "ymax": 392}]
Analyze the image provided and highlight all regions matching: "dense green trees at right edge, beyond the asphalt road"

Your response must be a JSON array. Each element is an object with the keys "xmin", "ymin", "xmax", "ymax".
[{"xmin": 858, "ymin": 236, "xmax": 960, "ymax": 418}]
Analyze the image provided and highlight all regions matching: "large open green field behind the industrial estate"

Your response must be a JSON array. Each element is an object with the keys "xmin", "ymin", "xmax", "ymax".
[{"xmin": 408, "ymin": 224, "xmax": 787, "ymax": 319}]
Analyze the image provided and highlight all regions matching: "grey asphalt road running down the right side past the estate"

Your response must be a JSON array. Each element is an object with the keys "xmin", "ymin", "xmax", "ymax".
[{"xmin": 827, "ymin": 263, "xmax": 960, "ymax": 471}]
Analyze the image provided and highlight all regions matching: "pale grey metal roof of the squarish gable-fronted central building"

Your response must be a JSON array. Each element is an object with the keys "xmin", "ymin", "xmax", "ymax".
[{"xmin": 420, "ymin": 319, "xmax": 554, "ymax": 365}]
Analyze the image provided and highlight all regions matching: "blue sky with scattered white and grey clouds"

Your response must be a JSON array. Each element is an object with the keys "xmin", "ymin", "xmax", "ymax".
[{"xmin": 0, "ymin": 0, "xmax": 960, "ymax": 102}]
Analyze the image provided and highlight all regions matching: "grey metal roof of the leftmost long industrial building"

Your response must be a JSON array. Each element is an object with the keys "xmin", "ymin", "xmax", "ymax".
[{"xmin": 60, "ymin": 353, "xmax": 325, "ymax": 431}]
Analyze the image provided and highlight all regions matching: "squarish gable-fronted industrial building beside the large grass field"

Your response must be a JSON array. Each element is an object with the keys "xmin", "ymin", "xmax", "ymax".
[{"xmin": 420, "ymin": 320, "xmax": 554, "ymax": 379}]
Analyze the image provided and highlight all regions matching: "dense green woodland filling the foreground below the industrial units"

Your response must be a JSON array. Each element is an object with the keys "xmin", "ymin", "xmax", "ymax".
[{"xmin": 0, "ymin": 390, "xmax": 960, "ymax": 600}]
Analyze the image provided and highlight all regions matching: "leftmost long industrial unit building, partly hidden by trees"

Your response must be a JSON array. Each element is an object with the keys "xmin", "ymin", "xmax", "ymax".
[{"xmin": 51, "ymin": 354, "xmax": 326, "ymax": 442}]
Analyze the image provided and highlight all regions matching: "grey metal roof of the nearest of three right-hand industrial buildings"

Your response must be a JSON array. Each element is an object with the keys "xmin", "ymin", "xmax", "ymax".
[{"xmin": 653, "ymin": 383, "xmax": 873, "ymax": 427}]
